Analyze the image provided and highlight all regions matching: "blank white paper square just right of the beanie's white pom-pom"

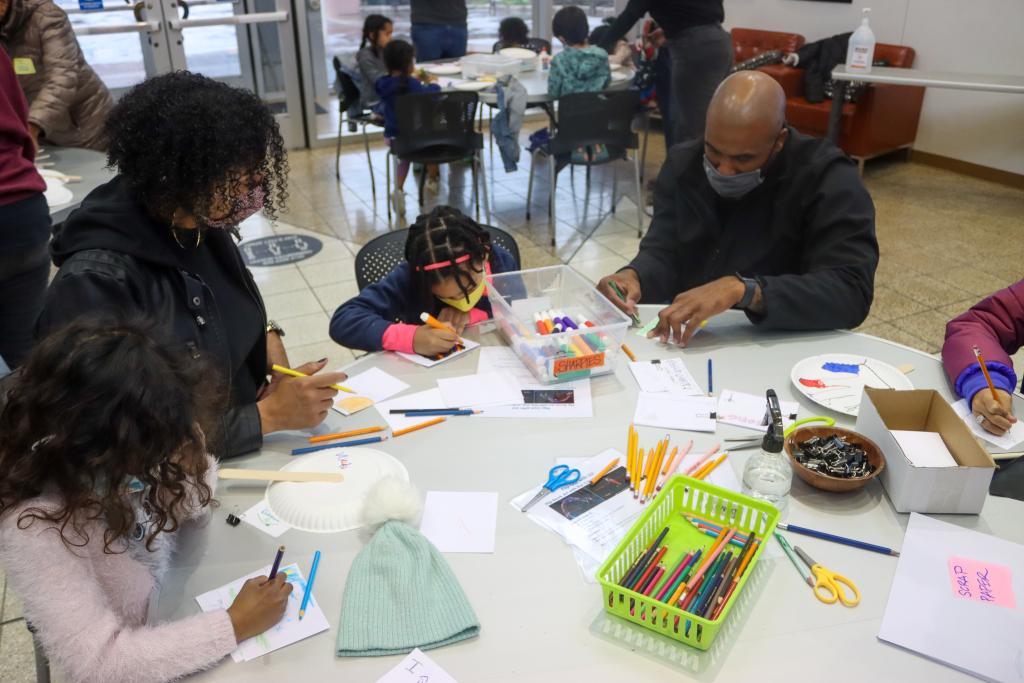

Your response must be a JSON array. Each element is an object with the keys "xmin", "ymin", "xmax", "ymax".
[{"xmin": 420, "ymin": 490, "xmax": 498, "ymax": 553}]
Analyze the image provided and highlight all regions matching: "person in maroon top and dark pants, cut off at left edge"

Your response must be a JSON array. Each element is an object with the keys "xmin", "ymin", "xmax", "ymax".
[{"xmin": 0, "ymin": 42, "xmax": 50, "ymax": 368}]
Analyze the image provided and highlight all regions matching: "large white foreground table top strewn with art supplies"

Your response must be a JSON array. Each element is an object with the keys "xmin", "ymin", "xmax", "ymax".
[{"xmin": 158, "ymin": 307, "xmax": 1024, "ymax": 683}]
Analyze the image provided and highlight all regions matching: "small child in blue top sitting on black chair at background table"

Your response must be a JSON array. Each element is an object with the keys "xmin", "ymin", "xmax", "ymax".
[{"xmin": 376, "ymin": 40, "xmax": 440, "ymax": 215}]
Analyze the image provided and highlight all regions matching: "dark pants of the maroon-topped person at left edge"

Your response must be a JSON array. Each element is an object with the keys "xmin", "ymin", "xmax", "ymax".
[{"xmin": 0, "ymin": 195, "xmax": 50, "ymax": 369}]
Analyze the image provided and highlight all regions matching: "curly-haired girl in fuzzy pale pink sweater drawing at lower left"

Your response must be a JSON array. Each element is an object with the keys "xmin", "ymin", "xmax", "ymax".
[{"xmin": 0, "ymin": 322, "xmax": 291, "ymax": 682}]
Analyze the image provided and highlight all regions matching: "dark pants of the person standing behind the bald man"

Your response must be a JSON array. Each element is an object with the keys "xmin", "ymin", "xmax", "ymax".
[{"xmin": 671, "ymin": 24, "xmax": 732, "ymax": 144}]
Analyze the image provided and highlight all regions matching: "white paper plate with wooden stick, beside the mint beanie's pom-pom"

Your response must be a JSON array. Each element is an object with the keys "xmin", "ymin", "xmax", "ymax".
[{"xmin": 266, "ymin": 449, "xmax": 409, "ymax": 533}]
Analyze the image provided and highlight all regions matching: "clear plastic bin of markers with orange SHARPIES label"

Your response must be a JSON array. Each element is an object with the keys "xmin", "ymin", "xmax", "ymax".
[{"xmin": 488, "ymin": 265, "xmax": 630, "ymax": 384}]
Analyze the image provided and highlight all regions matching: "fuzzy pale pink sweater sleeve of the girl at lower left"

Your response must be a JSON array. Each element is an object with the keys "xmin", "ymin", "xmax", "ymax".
[{"xmin": 3, "ymin": 528, "xmax": 237, "ymax": 682}]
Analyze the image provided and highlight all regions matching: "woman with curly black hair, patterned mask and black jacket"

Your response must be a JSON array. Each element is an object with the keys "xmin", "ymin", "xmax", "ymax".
[{"xmin": 37, "ymin": 72, "xmax": 345, "ymax": 457}]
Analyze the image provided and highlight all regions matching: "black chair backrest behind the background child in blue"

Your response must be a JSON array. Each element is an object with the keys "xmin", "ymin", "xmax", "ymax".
[{"xmin": 392, "ymin": 91, "xmax": 483, "ymax": 157}]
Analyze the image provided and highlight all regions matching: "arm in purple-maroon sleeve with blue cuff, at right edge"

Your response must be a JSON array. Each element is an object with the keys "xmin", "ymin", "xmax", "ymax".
[{"xmin": 942, "ymin": 280, "xmax": 1024, "ymax": 435}]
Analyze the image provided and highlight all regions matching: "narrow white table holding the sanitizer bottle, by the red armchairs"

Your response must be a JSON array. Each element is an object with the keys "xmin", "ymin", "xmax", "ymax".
[{"xmin": 827, "ymin": 65, "xmax": 1024, "ymax": 142}]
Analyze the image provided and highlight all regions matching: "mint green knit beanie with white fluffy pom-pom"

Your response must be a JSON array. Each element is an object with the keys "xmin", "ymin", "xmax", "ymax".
[{"xmin": 337, "ymin": 477, "xmax": 480, "ymax": 657}]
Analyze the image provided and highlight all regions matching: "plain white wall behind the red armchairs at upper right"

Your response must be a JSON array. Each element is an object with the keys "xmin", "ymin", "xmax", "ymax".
[{"xmin": 725, "ymin": 0, "xmax": 1024, "ymax": 175}]
